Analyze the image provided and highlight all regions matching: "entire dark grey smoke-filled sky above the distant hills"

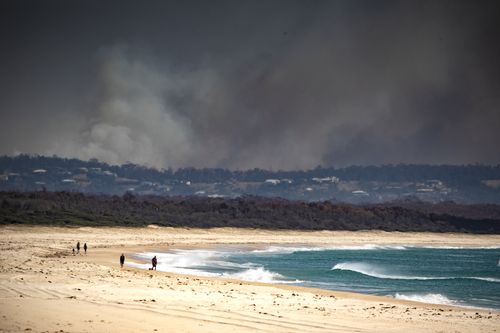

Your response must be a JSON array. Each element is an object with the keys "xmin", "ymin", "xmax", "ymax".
[{"xmin": 0, "ymin": 0, "xmax": 500, "ymax": 170}]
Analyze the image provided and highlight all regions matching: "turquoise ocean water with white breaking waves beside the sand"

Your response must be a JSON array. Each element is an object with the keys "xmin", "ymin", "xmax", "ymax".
[{"xmin": 129, "ymin": 245, "xmax": 500, "ymax": 310}]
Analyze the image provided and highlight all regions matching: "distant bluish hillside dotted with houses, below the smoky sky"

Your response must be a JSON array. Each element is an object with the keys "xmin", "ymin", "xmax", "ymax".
[{"xmin": 0, "ymin": 155, "xmax": 500, "ymax": 204}]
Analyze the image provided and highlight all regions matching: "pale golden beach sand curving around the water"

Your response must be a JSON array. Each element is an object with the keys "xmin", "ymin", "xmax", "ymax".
[{"xmin": 0, "ymin": 226, "xmax": 500, "ymax": 333}]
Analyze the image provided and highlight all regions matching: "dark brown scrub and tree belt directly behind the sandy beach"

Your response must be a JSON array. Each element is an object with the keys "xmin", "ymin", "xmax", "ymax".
[{"xmin": 0, "ymin": 192, "xmax": 500, "ymax": 234}]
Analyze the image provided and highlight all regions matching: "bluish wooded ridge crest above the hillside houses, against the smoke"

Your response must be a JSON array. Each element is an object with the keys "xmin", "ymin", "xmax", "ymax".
[{"xmin": 0, "ymin": 155, "xmax": 500, "ymax": 187}]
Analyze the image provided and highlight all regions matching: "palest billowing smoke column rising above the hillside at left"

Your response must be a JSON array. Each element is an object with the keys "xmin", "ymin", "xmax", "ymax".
[{"xmin": 53, "ymin": 47, "xmax": 193, "ymax": 167}]
